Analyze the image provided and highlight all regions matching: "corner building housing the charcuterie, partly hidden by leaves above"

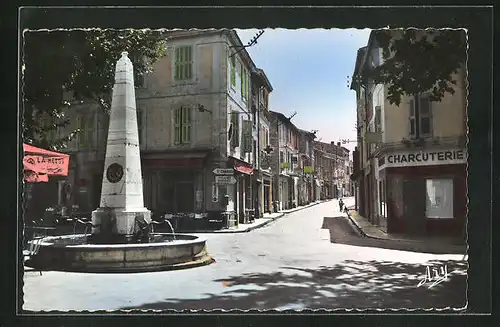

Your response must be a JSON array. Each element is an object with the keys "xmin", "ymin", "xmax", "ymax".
[{"xmin": 353, "ymin": 32, "xmax": 467, "ymax": 236}]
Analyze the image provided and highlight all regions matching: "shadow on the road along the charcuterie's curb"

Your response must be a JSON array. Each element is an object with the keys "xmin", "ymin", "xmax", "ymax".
[{"xmin": 321, "ymin": 216, "xmax": 466, "ymax": 254}]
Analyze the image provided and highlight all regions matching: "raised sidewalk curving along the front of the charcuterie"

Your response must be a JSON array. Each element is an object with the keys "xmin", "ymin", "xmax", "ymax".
[{"xmin": 348, "ymin": 206, "xmax": 467, "ymax": 254}]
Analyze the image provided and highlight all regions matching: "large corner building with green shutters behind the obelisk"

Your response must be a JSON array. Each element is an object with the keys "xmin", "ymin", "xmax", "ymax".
[{"xmin": 58, "ymin": 29, "xmax": 272, "ymax": 229}]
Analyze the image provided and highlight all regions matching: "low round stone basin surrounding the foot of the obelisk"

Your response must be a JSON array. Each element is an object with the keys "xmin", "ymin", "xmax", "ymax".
[{"xmin": 26, "ymin": 233, "xmax": 213, "ymax": 273}]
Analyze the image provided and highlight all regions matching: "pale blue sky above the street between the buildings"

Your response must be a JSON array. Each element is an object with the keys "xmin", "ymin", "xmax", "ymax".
[{"xmin": 236, "ymin": 29, "xmax": 370, "ymax": 151}]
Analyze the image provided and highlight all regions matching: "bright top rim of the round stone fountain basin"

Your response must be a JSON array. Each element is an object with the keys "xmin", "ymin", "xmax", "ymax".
[{"xmin": 35, "ymin": 233, "xmax": 207, "ymax": 250}]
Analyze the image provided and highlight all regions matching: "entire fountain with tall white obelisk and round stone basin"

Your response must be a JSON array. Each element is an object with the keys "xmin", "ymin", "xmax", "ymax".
[{"xmin": 26, "ymin": 52, "xmax": 213, "ymax": 272}]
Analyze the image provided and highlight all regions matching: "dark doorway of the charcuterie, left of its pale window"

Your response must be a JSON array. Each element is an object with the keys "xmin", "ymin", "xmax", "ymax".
[{"xmin": 403, "ymin": 179, "xmax": 425, "ymax": 235}]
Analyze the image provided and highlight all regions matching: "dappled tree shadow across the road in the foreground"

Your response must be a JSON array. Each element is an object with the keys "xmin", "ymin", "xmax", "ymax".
[{"xmin": 124, "ymin": 260, "xmax": 467, "ymax": 310}]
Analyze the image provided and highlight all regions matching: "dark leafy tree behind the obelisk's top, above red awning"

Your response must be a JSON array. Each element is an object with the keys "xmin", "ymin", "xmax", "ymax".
[{"xmin": 22, "ymin": 29, "xmax": 166, "ymax": 150}]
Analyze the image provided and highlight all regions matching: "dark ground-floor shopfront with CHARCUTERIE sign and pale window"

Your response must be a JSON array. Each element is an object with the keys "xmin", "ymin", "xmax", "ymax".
[{"xmin": 380, "ymin": 149, "xmax": 467, "ymax": 236}]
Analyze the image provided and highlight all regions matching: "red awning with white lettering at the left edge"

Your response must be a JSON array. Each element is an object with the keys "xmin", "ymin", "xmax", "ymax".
[{"xmin": 23, "ymin": 144, "xmax": 69, "ymax": 183}]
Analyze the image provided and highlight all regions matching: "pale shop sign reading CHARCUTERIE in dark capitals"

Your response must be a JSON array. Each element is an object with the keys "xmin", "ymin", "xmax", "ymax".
[{"xmin": 379, "ymin": 149, "xmax": 467, "ymax": 169}]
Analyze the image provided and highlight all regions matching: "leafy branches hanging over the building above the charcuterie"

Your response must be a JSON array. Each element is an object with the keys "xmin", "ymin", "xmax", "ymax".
[{"xmin": 363, "ymin": 29, "xmax": 467, "ymax": 105}]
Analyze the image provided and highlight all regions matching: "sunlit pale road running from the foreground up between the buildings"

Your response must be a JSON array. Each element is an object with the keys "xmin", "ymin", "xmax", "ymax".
[{"xmin": 23, "ymin": 199, "xmax": 466, "ymax": 311}]
